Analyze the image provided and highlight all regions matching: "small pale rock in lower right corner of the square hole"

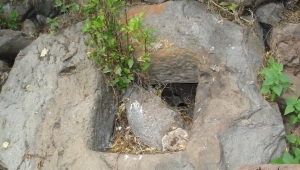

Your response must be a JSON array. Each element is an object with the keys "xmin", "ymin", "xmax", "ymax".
[{"xmin": 162, "ymin": 128, "xmax": 189, "ymax": 151}]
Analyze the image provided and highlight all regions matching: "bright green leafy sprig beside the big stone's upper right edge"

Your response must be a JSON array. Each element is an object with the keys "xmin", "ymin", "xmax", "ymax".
[{"xmin": 259, "ymin": 57, "xmax": 291, "ymax": 101}]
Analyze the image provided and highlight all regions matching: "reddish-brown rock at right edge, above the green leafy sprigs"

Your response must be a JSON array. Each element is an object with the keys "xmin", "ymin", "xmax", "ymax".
[{"xmin": 271, "ymin": 24, "xmax": 300, "ymax": 75}]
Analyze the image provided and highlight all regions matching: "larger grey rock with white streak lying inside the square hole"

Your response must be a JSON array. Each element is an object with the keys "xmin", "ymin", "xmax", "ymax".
[{"xmin": 123, "ymin": 87, "xmax": 184, "ymax": 150}]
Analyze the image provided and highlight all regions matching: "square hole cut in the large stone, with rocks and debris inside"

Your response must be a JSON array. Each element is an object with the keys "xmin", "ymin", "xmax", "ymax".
[{"xmin": 92, "ymin": 83, "xmax": 198, "ymax": 154}]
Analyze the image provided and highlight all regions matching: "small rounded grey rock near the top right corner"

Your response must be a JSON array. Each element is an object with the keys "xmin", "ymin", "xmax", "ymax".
[{"xmin": 255, "ymin": 3, "xmax": 284, "ymax": 26}]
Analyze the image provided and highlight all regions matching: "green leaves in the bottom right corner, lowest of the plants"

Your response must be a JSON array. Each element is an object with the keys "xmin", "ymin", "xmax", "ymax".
[{"xmin": 270, "ymin": 135, "xmax": 300, "ymax": 164}]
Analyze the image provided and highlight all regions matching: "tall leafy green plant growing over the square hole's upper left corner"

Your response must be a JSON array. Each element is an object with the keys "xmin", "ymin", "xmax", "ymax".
[{"xmin": 82, "ymin": 0, "xmax": 154, "ymax": 91}]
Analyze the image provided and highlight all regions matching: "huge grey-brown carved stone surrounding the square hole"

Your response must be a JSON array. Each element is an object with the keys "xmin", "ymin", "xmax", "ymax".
[{"xmin": 0, "ymin": 1, "xmax": 286, "ymax": 170}]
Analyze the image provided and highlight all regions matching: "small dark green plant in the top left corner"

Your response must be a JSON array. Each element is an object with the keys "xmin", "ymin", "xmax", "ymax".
[{"xmin": 0, "ymin": 3, "xmax": 19, "ymax": 30}]
